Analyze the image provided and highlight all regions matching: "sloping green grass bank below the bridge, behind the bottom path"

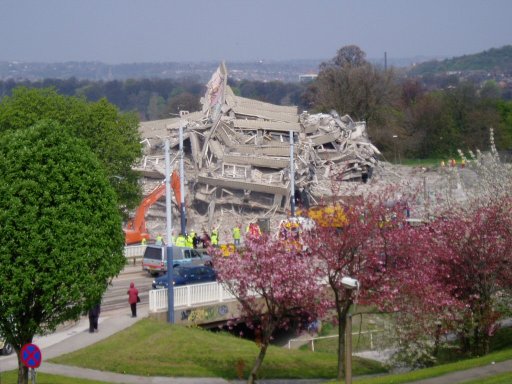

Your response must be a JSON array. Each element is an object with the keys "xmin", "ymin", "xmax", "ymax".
[{"xmin": 51, "ymin": 319, "xmax": 385, "ymax": 379}]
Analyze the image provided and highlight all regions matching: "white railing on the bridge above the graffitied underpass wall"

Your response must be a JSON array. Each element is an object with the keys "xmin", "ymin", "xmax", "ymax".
[{"xmin": 149, "ymin": 282, "xmax": 234, "ymax": 313}]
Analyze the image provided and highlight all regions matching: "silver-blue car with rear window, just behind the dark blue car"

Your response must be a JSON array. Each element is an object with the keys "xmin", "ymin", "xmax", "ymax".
[{"xmin": 142, "ymin": 245, "xmax": 212, "ymax": 276}]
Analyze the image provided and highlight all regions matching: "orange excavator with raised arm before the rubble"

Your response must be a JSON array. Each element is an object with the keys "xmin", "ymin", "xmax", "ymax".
[{"xmin": 123, "ymin": 171, "xmax": 181, "ymax": 245}]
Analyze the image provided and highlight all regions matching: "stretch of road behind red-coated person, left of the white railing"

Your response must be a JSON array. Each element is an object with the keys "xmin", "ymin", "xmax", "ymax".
[{"xmin": 101, "ymin": 264, "xmax": 153, "ymax": 313}]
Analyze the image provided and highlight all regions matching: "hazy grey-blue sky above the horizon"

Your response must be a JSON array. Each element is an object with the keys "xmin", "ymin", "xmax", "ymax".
[{"xmin": 0, "ymin": 0, "xmax": 512, "ymax": 64}]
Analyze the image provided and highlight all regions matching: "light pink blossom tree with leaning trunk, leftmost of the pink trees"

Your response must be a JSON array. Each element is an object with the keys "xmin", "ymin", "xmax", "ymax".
[{"xmin": 214, "ymin": 234, "xmax": 326, "ymax": 383}]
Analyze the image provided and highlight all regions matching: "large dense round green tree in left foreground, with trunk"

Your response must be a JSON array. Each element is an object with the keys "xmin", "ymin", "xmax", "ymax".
[{"xmin": 0, "ymin": 120, "xmax": 125, "ymax": 383}]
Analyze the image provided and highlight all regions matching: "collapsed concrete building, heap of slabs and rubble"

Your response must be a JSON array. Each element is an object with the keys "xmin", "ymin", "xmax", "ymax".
[{"xmin": 137, "ymin": 63, "xmax": 380, "ymax": 237}]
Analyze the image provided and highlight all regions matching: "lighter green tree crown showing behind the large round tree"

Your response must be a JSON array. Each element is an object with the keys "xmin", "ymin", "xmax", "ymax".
[{"xmin": 0, "ymin": 87, "xmax": 142, "ymax": 218}]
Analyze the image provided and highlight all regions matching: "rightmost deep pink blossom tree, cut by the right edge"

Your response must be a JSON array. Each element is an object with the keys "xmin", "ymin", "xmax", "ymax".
[{"xmin": 435, "ymin": 201, "xmax": 512, "ymax": 355}]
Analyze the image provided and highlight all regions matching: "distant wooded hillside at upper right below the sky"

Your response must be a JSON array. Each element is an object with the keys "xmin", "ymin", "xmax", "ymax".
[{"xmin": 409, "ymin": 45, "xmax": 512, "ymax": 76}]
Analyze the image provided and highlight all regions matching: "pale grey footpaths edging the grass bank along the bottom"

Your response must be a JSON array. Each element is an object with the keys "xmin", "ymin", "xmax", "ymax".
[{"xmin": 0, "ymin": 296, "xmax": 512, "ymax": 384}]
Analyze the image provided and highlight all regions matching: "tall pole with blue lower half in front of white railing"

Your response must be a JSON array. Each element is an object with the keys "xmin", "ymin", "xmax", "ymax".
[{"xmin": 165, "ymin": 139, "xmax": 174, "ymax": 324}]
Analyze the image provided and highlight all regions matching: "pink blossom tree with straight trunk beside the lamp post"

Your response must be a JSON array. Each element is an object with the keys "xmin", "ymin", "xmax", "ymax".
[{"xmin": 302, "ymin": 197, "xmax": 402, "ymax": 379}]
